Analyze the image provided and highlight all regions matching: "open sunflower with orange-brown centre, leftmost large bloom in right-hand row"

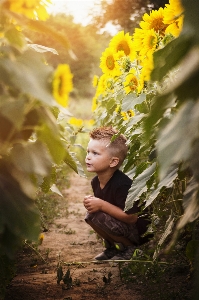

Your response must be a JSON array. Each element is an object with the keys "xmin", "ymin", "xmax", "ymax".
[{"xmin": 100, "ymin": 48, "xmax": 121, "ymax": 77}]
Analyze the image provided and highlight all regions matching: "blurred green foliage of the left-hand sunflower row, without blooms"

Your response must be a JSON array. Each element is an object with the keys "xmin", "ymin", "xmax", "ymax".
[{"xmin": 0, "ymin": 1, "xmax": 87, "ymax": 287}]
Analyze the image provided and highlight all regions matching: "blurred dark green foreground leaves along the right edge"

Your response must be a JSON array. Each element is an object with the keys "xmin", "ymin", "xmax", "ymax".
[{"xmin": 145, "ymin": 1, "xmax": 199, "ymax": 244}]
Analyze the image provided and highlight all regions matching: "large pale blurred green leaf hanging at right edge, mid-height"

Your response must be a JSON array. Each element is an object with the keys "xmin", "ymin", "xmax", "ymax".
[{"xmin": 157, "ymin": 101, "xmax": 199, "ymax": 179}]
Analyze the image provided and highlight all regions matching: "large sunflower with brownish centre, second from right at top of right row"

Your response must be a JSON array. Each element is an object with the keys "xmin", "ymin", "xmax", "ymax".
[{"xmin": 140, "ymin": 7, "xmax": 167, "ymax": 34}]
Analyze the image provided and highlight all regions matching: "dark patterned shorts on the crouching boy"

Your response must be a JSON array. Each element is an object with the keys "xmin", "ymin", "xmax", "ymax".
[{"xmin": 85, "ymin": 211, "xmax": 139, "ymax": 245}]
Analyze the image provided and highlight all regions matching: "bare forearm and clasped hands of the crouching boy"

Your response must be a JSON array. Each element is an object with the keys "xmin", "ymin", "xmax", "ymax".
[{"xmin": 84, "ymin": 195, "xmax": 138, "ymax": 224}]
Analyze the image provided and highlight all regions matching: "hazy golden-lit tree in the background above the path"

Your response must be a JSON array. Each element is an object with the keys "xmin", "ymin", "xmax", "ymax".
[{"xmin": 27, "ymin": 14, "xmax": 110, "ymax": 99}]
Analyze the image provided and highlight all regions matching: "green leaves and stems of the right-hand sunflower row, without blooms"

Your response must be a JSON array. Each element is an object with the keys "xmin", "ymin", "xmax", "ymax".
[{"xmin": 95, "ymin": 0, "xmax": 199, "ymax": 259}]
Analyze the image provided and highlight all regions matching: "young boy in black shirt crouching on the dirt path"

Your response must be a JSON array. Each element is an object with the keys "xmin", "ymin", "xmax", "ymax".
[{"xmin": 83, "ymin": 127, "xmax": 149, "ymax": 260}]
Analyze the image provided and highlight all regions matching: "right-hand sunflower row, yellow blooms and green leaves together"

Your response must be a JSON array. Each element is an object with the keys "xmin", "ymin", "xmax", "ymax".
[{"xmin": 92, "ymin": 0, "xmax": 199, "ymax": 260}]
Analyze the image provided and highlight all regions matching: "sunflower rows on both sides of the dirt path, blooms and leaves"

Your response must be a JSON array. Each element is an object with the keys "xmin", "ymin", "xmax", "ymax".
[{"xmin": 0, "ymin": 0, "xmax": 199, "ymax": 296}]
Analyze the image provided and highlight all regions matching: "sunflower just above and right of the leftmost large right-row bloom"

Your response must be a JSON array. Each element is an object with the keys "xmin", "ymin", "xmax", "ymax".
[{"xmin": 109, "ymin": 31, "xmax": 135, "ymax": 60}]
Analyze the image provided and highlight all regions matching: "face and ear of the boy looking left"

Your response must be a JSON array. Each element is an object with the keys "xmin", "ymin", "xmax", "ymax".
[{"xmin": 85, "ymin": 139, "xmax": 118, "ymax": 174}]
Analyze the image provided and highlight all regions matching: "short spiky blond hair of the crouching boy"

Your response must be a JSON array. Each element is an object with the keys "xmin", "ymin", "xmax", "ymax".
[{"xmin": 90, "ymin": 127, "xmax": 128, "ymax": 166}]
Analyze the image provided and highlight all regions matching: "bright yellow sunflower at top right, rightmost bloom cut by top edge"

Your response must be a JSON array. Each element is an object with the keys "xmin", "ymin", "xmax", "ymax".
[{"xmin": 163, "ymin": 0, "xmax": 184, "ymax": 37}]
